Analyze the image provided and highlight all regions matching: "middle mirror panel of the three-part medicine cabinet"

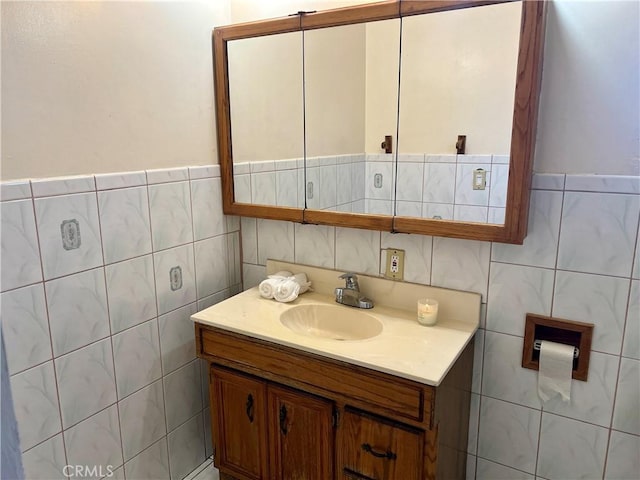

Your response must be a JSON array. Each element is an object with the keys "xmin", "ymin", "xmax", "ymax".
[{"xmin": 304, "ymin": 18, "xmax": 400, "ymax": 215}]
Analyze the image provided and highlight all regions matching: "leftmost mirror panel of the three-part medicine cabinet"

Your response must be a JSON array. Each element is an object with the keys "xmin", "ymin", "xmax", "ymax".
[{"xmin": 227, "ymin": 32, "xmax": 304, "ymax": 208}]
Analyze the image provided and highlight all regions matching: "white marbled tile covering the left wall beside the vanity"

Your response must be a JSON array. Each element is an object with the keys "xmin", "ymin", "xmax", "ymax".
[{"xmin": 0, "ymin": 166, "xmax": 241, "ymax": 480}]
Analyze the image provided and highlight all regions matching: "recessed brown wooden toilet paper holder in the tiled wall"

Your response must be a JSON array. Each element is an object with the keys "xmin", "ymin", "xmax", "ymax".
[{"xmin": 522, "ymin": 313, "xmax": 593, "ymax": 381}]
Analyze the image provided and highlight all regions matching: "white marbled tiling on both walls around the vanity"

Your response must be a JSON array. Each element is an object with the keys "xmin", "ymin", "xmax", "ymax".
[{"xmin": 6, "ymin": 166, "xmax": 640, "ymax": 480}]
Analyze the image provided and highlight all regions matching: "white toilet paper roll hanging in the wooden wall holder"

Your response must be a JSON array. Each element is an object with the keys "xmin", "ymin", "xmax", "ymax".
[{"xmin": 538, "ymin": 340, "xmax": 573, "ymax": 402}]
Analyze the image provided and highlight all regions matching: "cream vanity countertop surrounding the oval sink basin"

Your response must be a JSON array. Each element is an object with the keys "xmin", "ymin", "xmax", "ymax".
[{"xmin": 191, "ymin": 287, "xmax": 480, "ymax": 386}]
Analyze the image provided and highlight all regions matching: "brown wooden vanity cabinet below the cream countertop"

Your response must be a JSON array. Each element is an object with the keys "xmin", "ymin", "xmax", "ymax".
[{"xmin": 195, "ymin": 323, "xmax": 473, "ymax": 480}]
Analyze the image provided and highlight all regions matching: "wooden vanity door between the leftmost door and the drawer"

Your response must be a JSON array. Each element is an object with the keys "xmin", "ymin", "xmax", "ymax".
[{"xmin": 268, "ymin": 385, "xmax": 334, "ymax": 480}]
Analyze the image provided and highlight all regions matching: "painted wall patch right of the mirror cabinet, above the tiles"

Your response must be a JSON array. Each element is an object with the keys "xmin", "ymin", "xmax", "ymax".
[{"xmin": 534, "ymin": 0, "xmax": 640, "ymax": 175}]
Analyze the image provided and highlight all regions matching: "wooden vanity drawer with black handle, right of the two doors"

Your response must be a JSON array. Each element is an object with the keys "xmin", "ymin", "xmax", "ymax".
[{"xmin": 338, "ymin": 408, "xmax": 424, "ymax": 480}]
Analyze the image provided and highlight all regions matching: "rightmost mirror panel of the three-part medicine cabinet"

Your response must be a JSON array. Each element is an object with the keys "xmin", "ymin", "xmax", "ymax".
[{"xmin": 396, "ymin": 2, "xmax": 522, "ymax": 224}]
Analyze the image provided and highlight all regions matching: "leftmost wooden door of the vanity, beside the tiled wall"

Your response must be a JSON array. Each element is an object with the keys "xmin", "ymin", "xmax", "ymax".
[{"xmin": 211, "ymin": 366, "xmax": 268, "ymax": 480}]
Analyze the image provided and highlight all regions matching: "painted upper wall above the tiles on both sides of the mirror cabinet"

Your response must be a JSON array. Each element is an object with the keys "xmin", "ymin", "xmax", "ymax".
[{"xmin": 0, "ymin": 0, "xmax": 640, "ymax": 180}]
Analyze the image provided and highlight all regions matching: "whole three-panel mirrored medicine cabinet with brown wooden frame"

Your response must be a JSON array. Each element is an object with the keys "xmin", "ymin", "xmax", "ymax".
[{"xmin": 213, "ymin": 0, "xmax": 545, "ymax": 243}]
